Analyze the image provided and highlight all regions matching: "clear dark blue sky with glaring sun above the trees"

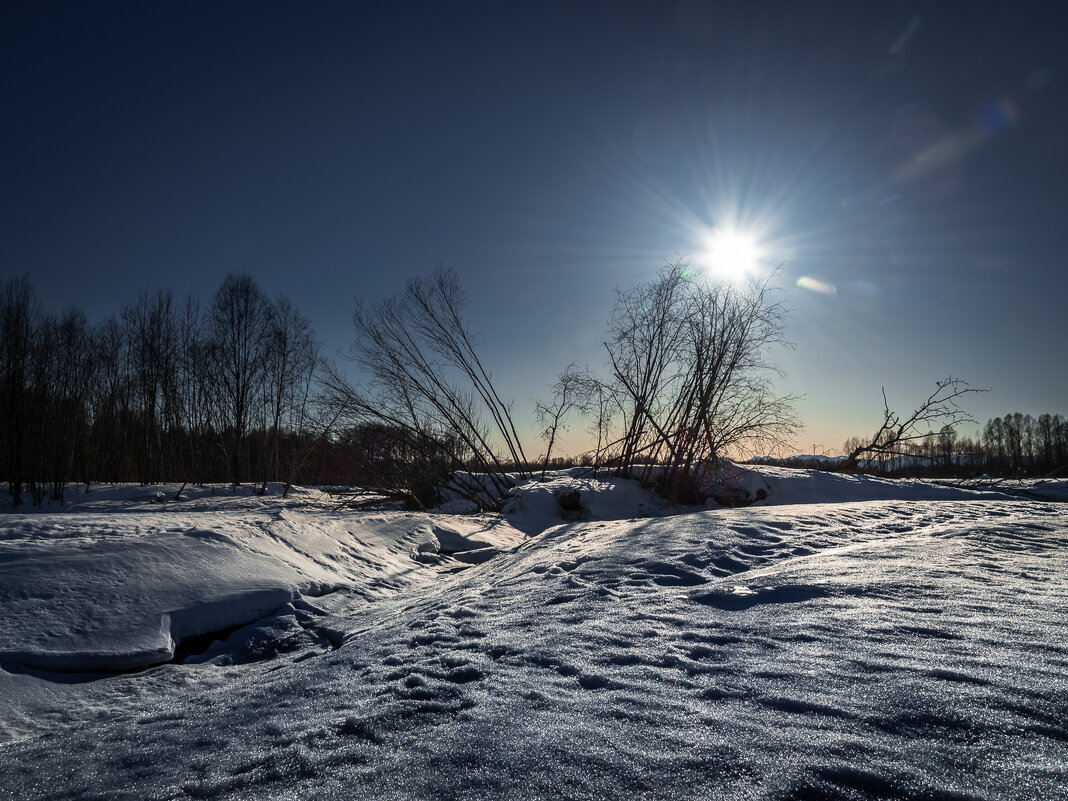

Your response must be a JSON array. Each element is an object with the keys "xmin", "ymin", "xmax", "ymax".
[{"xmin": 0, "ymin": 0, "xmax": 1068, "ymax": 452}]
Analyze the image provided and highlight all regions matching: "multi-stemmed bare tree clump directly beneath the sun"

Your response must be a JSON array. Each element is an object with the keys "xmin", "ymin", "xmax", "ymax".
[{"xmin": 604, "ymin": 261, "xmax": 797, "ymax": 499}]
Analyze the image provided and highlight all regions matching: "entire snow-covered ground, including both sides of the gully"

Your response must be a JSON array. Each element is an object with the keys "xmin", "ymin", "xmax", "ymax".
[{"xmin": 0, "ymin": 469, "xmax": 1068, "ymax": 801}]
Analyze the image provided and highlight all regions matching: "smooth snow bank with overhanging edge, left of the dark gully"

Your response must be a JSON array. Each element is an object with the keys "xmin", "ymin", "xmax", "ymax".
[{"xmin": 0, "ymin": 488, "xmax": 520, "ymax": 673}]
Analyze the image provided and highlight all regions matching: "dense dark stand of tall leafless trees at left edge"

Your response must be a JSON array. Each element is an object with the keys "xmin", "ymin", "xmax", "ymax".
[{"xmin": 0, "ymin": 274, "xmax": 321, "ymax": 505}]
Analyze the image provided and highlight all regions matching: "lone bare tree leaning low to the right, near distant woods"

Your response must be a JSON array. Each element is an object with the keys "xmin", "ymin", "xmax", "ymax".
[{"xmin": 842, "ymin": 376, "xmax": 987, "ymax": 470}]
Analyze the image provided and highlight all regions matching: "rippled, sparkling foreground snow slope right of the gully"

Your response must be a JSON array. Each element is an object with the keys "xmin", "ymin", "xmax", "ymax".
[{"xmin": 0, "ymin": 480, "xmax": 1068, "ymax": 801}]
